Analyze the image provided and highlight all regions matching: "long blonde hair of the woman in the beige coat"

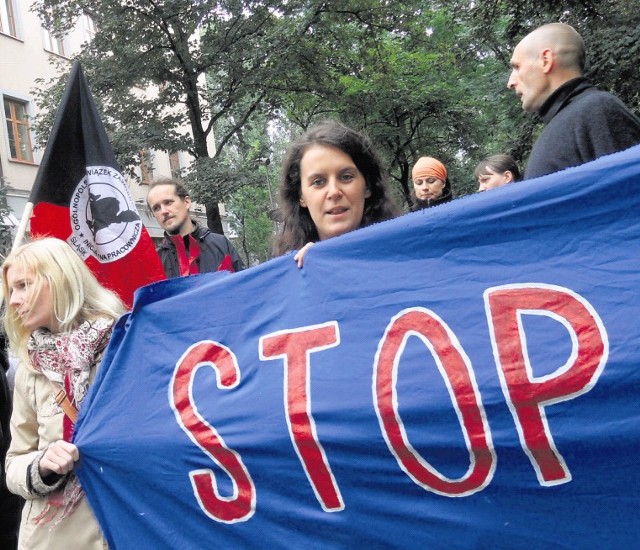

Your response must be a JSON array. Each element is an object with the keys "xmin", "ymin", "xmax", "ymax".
[{"xmin": 2, "ymin": 237, "xmax": 125, "ymax": 365}]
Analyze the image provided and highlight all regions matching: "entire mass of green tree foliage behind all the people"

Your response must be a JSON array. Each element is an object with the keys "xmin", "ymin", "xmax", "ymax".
[{"xmin": 31, "ymin": 0, "xmax": 640, "ymax": 246}]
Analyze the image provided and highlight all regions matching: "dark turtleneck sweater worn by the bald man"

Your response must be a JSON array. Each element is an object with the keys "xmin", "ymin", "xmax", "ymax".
[{"xmin": 524, "ymin": 77, "xmax": 640, "ymax": 179}]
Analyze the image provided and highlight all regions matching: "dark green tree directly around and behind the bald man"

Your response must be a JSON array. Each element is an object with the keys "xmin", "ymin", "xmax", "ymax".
[{"xmin": 449, "ymin": 0, "xmax": 640, "ymax": 172}]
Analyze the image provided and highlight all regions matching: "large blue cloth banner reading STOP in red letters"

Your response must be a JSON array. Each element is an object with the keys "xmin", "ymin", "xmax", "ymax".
[{"xmin": 75, "ymin": 147, "xmax": 640, "ymax": 549}]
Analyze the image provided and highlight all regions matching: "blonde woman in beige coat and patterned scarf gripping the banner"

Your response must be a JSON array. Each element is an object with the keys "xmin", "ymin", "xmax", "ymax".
[{"xmin": 2, "ymin": 238, "xmax": 124, "ymax": 550}]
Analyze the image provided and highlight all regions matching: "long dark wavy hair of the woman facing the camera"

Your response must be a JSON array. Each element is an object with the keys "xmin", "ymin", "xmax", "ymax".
[{"xmin": 274, "ymin": 120, "xmax": 399, "ymax": 254}]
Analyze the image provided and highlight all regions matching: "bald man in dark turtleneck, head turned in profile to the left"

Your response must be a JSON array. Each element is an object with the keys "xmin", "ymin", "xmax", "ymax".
[{"xmin": 507, "ymin": 23, "xmax": 640, "ymax": 179}]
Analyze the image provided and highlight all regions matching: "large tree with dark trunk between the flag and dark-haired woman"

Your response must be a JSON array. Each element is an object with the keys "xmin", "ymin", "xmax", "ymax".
[{"xmin": 35, "ymin": 0, "xmax": 321, "ymax": 232}]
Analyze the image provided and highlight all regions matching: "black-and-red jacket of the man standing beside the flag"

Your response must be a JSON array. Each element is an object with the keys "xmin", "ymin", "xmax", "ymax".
[{"xmin": 158, "ymin": 222, "xmax": 244, "ymax": 278}]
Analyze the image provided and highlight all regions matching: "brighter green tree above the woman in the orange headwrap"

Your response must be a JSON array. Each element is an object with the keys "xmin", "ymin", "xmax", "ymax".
[{"xmin": 272, "ymin": 0, "xmax": 488, "ymax": 203}]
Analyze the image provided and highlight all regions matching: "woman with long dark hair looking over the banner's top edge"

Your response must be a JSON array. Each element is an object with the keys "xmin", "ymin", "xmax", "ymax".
[{"xmin": 275, "ymin": 121, "xmax": 399, "ymax": 267}]
